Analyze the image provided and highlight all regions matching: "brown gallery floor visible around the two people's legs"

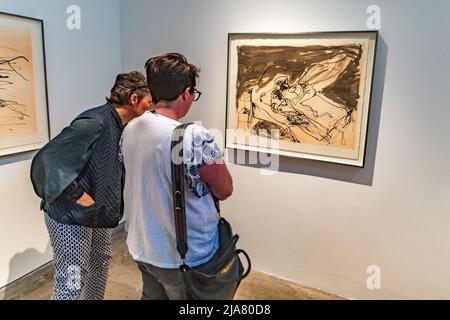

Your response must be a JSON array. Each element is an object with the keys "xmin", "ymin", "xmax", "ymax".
[{"xmin": 5, "ymin": 232, "xmax": 342, "ymax": 300}]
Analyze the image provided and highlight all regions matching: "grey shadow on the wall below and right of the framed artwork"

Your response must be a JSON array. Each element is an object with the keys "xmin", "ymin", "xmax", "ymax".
[{"xmin": 227, "ymin": 34, "xmax": 388, "ymax": 186}]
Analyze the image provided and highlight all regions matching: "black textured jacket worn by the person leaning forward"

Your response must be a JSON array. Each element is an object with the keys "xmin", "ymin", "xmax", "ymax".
[{"xmin": 31, "ymin": 103, "xmax": 124, "ymax": 228}]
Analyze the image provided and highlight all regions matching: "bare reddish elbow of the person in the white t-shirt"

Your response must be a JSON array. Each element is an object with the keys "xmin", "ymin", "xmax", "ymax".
[{"xmin": 199, "ymin": 164, "xmax": 233, "ymax": 201}]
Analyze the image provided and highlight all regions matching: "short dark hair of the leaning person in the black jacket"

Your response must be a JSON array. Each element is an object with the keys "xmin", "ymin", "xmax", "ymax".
[{"xmin": 106, "ymin": 71, "xmax": 150, "ymax": 106}]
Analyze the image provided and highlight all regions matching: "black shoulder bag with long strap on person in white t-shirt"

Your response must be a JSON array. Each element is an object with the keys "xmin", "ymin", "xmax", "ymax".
[{"xmin": 172, "ymin": 124, "xmax": 251, "ymax": 300}]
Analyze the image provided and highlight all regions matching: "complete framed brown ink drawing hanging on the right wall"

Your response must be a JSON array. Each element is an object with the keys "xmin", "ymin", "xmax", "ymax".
[{"xmin": 225, "ymin": 31, "xmax": 378, "ymax": 167}]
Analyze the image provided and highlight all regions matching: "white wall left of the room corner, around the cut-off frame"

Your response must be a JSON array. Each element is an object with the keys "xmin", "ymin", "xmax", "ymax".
[{"xmin": 0, "ymin": 0, "xmax": 121, "ymax": 288}]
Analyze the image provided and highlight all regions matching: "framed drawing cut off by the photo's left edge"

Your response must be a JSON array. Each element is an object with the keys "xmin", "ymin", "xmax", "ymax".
[{"xmin": 0, "ymin": 13, "xmax": 50, "ymax": 156}]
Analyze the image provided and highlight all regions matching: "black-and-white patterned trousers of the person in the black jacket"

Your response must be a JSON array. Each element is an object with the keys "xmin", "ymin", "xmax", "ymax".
[{"xmin": 45, "ymin": 215, "xmax": 112, "ymax": 300}]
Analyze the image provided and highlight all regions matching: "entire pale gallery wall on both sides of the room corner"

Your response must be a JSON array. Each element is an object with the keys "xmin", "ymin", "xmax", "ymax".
[{"xmin": 0, "ymin": 0, "xmax": 450, "ymax": 299}]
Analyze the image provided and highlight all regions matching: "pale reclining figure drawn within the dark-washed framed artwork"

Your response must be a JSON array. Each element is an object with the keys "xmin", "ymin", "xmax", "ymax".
[{"xmin": 253, "ymin": 54, "xmax": 354, "ymax": 144}]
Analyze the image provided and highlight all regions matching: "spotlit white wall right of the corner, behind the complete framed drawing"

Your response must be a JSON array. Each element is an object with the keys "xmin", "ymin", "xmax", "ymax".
[{"xmin": 121, "ymin": 0, "xmax": 450, "ymax": 299}]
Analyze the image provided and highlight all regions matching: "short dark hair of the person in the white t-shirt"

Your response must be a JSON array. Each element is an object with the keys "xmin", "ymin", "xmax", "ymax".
[{"xmin": 145, "ymin": 53, "xmax": 200, "ymax": 102}]
